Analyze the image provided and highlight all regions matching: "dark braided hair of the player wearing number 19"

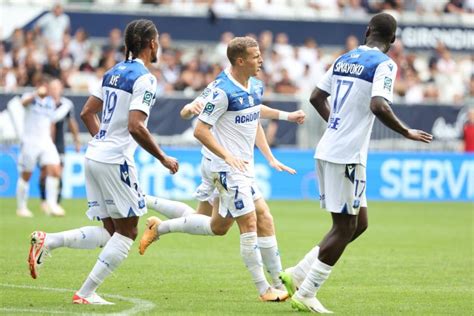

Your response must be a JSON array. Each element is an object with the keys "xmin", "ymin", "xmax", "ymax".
[{"xmin": 125, "ymin": 19, "xmax": 158, "ymax": 60}]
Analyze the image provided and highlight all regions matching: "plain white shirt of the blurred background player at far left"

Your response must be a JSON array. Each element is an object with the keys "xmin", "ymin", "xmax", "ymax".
[{"xmin": 22, "ymin": 95, "xmax": 72, "ymax": 145}]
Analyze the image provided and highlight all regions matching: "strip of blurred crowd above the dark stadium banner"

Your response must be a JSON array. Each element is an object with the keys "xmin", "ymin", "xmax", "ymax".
[{"xmin": 4, "ymin": 0, "xmax": 474, "ymax": 19}]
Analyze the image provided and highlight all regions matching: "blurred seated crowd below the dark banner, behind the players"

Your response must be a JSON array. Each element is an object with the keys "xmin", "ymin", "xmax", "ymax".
[{"xmin": 0, "ymin": 0, "xmax": 474, "ymax": 104}]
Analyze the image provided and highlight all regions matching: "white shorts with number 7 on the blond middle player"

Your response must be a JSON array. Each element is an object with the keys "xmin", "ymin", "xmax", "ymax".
[{"xmin": 212, "ymin": 172, "xmax": 255, "ymax": 218}]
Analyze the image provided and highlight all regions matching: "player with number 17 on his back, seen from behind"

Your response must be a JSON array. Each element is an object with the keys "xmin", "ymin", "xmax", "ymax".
[{"xmin": 281, "ymin": 13, "xmax": 432, "ymax": 313}]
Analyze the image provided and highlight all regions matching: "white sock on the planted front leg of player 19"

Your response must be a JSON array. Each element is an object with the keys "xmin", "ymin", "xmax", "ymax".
[{"xmin": 78, "ymin": 232, "xmax": 133, "ymax": 297}]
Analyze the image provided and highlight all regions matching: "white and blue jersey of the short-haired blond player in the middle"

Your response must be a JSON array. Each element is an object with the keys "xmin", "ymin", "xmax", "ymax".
[{"xmin": 197, "ymin": 70, "xmax": 263, "ymax": 177}]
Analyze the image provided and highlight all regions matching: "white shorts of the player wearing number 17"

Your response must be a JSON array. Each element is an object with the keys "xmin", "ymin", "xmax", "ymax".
[{"xmin": 316, "ymin": 159, "xmax": 367, "ymax": 215}]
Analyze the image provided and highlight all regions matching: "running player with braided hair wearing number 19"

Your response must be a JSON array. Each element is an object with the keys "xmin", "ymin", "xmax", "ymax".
[{"xmin": 29, "ymin": 20, "xmax": 178, "ymax": 304}]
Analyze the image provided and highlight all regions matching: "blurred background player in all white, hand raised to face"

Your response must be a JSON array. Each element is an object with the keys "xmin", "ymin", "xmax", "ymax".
[{"xmin": 16, "ymin": 80, "xmax": 71, "ymax": 217}]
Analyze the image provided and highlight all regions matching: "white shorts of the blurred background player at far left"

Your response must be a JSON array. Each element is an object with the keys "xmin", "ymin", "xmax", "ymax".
[{"xmin": 18, "ymin": 141, "xmax": 60, "ymax": 172}]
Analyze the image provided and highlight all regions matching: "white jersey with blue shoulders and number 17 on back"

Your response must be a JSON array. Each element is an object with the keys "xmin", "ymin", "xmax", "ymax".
[{"xmin": 314, "ymin": 46, "xmax": 397, "ymax": 166}]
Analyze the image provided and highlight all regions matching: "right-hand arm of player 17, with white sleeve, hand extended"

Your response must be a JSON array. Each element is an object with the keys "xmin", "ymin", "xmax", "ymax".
[{"xmin": 370, "ymin": 60, "xmax": 433, "ymax": 143}]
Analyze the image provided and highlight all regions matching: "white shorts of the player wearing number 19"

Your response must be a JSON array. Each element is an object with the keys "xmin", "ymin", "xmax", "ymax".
[{"xmin": 84, "ymin": 158, "xmax": 147, "ymax": 219}]
